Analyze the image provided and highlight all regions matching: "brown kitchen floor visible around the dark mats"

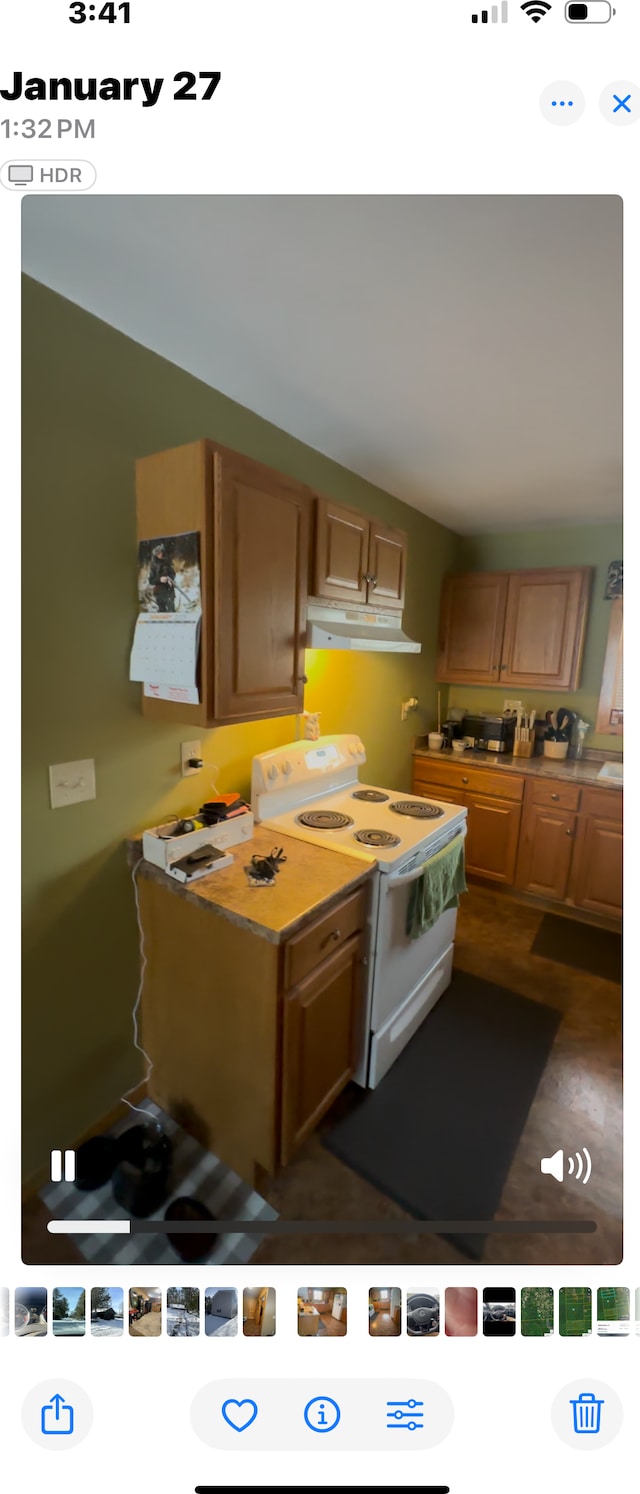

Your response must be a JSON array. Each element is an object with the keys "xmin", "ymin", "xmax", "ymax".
[{"xmin": 254, "ymin": 887, "xmax": 622, "ymax": 1268}]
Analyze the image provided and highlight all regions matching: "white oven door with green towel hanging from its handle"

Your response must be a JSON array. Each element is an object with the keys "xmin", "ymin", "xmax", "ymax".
[{"xmin": 371, "ymin": 823, "xmax": 467, "ymax": 1032}]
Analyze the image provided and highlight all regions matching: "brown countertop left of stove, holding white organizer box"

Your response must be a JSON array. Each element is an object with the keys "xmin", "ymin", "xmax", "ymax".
[{"xmin": 127, "ymin": 825, "xmax": 375, "ymax": 944}]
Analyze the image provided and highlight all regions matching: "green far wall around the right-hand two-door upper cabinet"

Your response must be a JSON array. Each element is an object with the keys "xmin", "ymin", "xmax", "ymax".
[{"xmin": 449, "ymin": 523, "xmax": 622, "ymax": 751}]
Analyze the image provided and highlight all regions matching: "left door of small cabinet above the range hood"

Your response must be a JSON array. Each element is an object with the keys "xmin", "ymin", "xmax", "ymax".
[{"xmin": 313, "ymin": 498, "xmax": 369, "ymax": 604}]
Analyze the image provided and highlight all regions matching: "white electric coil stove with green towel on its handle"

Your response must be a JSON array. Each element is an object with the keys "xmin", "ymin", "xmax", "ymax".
[{"xmin": 251, "ymin": 735, "xmax": 467, "ymax": 1089}]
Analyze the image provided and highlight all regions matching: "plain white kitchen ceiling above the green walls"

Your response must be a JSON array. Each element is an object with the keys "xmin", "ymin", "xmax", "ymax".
[{"xmin": 22, "ymin": 196, "xmax": 622, "ymax": 533}]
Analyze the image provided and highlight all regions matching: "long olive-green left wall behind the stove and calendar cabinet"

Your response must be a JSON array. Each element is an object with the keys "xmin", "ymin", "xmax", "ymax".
[{"xmin": 22, "ymin": 279, "xmax": 459, "ymax": 1174}]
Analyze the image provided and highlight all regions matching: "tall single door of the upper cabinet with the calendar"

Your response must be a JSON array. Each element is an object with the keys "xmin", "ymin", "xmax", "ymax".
[{"xmin": 212, "ymin": 451, "xmax": 311, "ymax": 722}]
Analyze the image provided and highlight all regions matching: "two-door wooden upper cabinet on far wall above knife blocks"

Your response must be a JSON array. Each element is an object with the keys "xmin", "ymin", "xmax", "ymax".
[{"xmin": 437, "ymin": 566, "xmax": 592, "ymax": 690}]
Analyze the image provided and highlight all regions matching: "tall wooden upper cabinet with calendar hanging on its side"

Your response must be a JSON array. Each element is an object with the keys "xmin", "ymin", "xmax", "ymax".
[{"xmin": 136, "ymin": 441, "xmax": 313, "ymax": 726}]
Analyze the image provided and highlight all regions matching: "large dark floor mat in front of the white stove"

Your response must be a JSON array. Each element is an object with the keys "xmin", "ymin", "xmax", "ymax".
[{"xmin": 323, "ymin": 971, "xmax": 561, "ymax": 1259}]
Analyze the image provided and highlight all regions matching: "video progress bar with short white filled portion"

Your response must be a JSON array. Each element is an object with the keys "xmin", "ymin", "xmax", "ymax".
[{"xmin": 46, "ymin": 1219, "xmax": 598, "ymax": 1234}]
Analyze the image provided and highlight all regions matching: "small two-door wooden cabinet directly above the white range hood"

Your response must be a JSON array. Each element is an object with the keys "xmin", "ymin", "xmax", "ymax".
[{"xmin": 311, "ymin": 498, "xmax": 407, "ymax": 611}]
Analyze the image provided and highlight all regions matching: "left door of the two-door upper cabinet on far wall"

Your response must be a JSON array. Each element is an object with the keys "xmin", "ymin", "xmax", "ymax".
[{"xmin": 435, "ymin": 571, "xmax": 508, "ymax": 684}]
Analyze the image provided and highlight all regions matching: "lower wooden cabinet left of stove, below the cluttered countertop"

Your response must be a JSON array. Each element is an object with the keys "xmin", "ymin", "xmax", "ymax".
[{"xmin": 138, "ymin": 852, "xmax": 369, "ymax": 1188}]
